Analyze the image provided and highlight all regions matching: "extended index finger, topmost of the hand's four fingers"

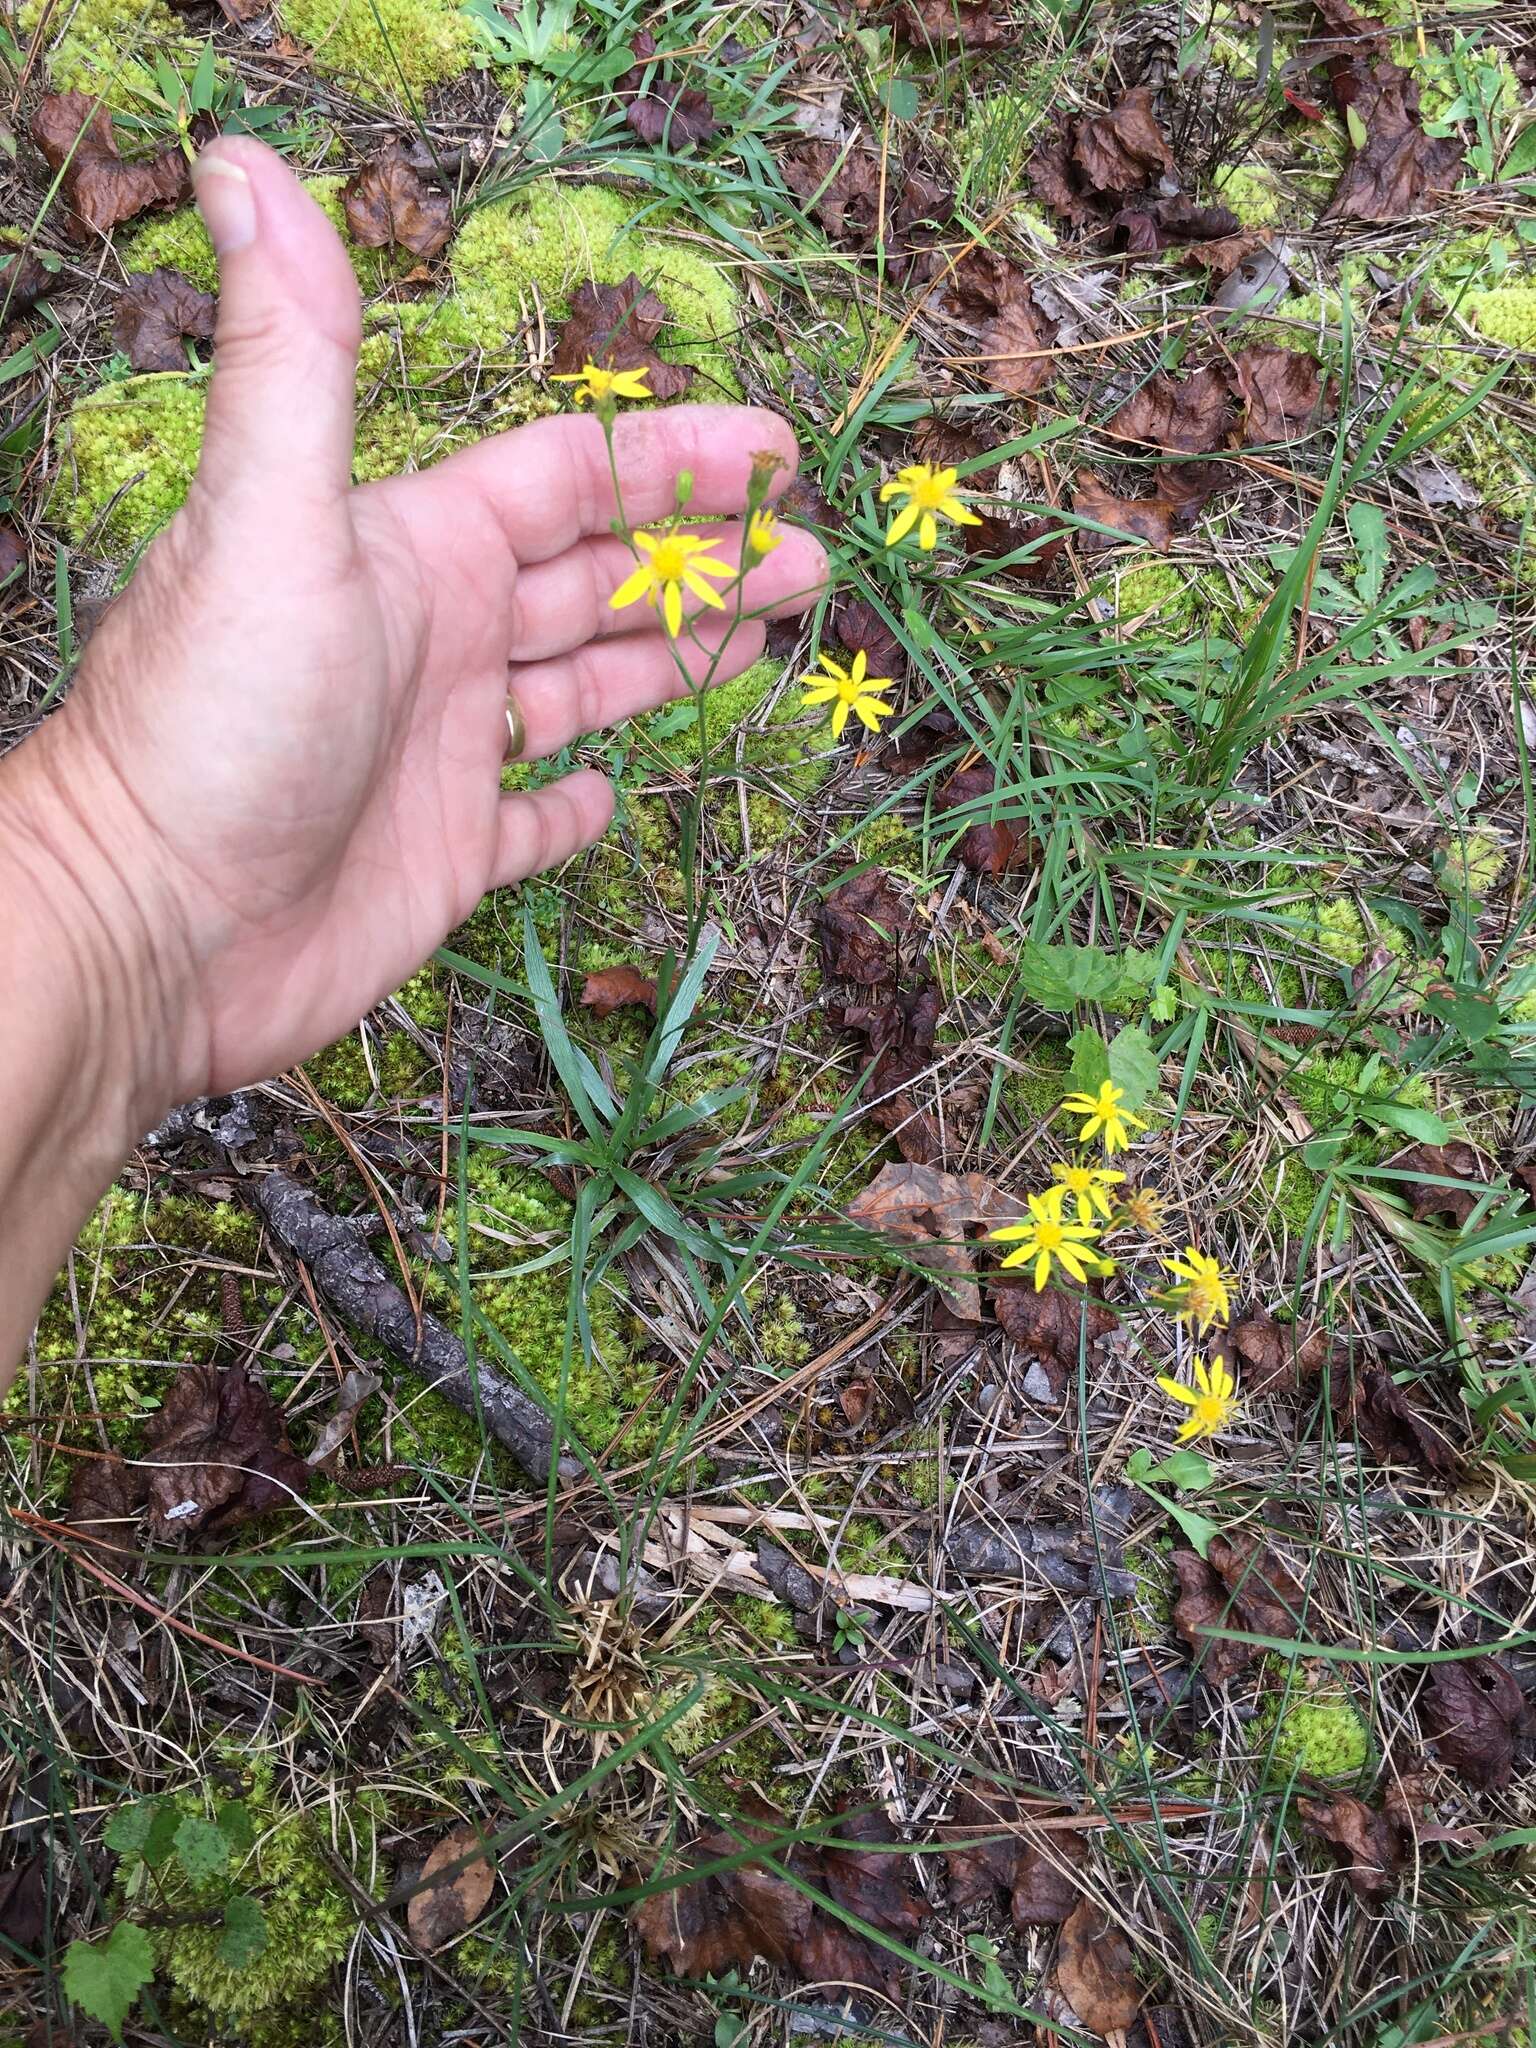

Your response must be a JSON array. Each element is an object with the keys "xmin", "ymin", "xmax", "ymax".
[{"xmin": 412, "ymin": 406, "xmax": 797, "ymax": 561}]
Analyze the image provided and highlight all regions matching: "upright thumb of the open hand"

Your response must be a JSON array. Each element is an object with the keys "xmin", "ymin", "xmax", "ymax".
[{"xmin": 193, "ymin": 135, "xmax": 360, "ymax": 496}]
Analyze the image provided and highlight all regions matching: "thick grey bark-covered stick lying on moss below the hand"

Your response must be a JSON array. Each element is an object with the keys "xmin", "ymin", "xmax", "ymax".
[{"xmin": 256, "ymin": 1174, "xmax": 580, "ymax": 1485}]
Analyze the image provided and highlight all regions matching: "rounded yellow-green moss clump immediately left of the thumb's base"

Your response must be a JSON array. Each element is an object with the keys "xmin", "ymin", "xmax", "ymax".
[{"xmin": 49, "ymin": 377, "xmax": 207, "ymax": 549}]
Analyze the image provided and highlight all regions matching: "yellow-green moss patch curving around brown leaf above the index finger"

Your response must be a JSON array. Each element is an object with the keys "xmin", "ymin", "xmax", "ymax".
[{"xmin": 451, "ymin": 178, "xmax": 741, "ymax": 399}]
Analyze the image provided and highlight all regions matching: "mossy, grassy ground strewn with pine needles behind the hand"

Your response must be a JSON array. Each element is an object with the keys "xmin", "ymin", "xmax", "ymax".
[{"xmin": 0, "ymin": 0, "xmax": 1536, "ymax": 2048}]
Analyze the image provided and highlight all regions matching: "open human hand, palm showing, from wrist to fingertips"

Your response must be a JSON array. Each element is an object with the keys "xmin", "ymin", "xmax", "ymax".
[{"xmin": 12, "ymin": 139, "xmax": 825, "ymax": 1106}]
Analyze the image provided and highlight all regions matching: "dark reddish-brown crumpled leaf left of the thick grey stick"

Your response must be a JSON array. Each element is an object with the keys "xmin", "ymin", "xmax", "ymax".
[{"xmin": 143, "ymin": 1366, "xmax": 313, "ymax": 1542}]
